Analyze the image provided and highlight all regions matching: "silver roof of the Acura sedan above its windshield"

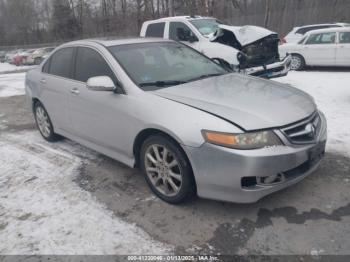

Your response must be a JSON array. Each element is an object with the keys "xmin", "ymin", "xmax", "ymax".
[{"xmin": 64, "ymin": 37, "xmax": 174, "ymax": 47}]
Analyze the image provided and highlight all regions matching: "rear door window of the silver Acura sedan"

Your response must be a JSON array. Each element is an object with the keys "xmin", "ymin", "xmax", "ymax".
[{"xmin": 49, "ymin": 47, "xmax": 74, "ymax": 78}]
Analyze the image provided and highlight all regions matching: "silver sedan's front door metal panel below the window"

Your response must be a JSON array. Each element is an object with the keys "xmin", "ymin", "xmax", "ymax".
[{"xmin": 69, "ymin": 82, "xmax": 131, "ymax": 154}]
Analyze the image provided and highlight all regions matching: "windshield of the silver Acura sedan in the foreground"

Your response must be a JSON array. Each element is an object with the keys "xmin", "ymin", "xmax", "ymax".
[{"xmin": 109, "ymin": 42, "xmax": 227, "ymax": 91}]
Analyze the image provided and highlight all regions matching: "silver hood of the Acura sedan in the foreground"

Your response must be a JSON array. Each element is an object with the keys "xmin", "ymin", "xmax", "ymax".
[{"xmin": 153, "ymin": 73, "xmax": 316, "ymax": 131}]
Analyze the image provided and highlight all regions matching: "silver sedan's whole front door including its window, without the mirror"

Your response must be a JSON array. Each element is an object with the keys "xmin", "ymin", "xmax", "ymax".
[{"xmin": 69, "ymin": 47, "xmax": 132, "ymax": 155}]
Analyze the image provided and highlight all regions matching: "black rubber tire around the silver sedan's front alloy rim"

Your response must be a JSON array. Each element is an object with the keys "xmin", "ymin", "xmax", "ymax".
[{"xmin": 140, "ymin": 135, "xmax": 196, "ymax": 204}]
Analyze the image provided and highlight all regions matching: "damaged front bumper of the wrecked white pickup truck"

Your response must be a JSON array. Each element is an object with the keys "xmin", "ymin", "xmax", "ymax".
[{"xmin": 241, "ymin": 55, "xmax": 292, "ymax": 78}]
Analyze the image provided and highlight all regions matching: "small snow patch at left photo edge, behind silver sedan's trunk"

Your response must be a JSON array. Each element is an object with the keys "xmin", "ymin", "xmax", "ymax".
[{"xmin": 0, "ymin": 73, "xmax": 25, "ymax": 97}]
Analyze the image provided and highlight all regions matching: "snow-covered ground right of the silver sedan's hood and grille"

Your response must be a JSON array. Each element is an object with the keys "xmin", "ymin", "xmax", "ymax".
[{"xmin": 275, "ymin": 71, "xmax": 350, "ymax": 158}]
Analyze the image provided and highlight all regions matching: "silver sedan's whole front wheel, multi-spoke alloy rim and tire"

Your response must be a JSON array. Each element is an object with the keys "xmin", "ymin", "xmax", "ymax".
[{"xmin": 140, "ymin": 135, "xmax": 195, "ymax": 204}]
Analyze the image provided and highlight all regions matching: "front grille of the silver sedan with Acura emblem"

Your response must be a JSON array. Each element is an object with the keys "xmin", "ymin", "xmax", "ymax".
[{"xmin": 281, "ymin": 112, "xmax": 321, "ymax": 144}]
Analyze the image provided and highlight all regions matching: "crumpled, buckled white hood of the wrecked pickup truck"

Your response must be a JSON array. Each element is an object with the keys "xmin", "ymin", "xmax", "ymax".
[{"xmin": 209, "ymin": 25, "xmax": 276, "ymax": 46}]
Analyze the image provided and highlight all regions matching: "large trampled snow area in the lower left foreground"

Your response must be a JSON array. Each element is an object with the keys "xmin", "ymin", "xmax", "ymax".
[{"xmin": 0, "ymin": 131, "xmax": 173, "ymax": 255}]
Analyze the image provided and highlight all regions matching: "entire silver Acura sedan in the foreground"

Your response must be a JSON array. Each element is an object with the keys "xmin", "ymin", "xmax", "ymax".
[{"xmin": 26, "ymin": 38, "xmax": 327, "ymax": 203}]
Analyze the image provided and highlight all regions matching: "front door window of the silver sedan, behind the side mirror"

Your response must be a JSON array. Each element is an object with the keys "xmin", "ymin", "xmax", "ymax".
[{"xmin": 74, "ymin": 47, "xmax": 116, "ymax": 83}]
